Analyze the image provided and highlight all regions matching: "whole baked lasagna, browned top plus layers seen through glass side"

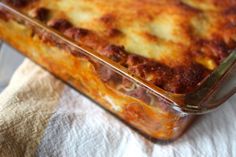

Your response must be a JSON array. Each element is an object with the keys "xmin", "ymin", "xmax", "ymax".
[{"xmin": 0, "ymin": 0, "xmax": 236, "ymax": 140}]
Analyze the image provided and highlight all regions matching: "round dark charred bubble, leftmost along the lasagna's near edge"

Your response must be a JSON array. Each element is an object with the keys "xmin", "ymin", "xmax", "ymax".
[{"xmin": 29, "ymin": 7, "xmax": 50, "ymax": 22}]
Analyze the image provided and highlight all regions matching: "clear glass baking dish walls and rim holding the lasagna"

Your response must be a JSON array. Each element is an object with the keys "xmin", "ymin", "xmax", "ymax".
[{"xmin": 0, "ymin": 2, "xmax": 236, "ymax": 141}]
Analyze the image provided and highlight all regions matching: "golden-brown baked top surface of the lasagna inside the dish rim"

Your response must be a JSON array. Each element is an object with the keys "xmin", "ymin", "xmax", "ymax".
[{"xmin": 5, "ymin": 0, "xmax": 236, "ymax": 93}]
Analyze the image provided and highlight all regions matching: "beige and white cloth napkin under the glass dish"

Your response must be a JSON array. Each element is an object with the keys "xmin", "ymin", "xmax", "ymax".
[{"xmin": 0, "ymin": 60, "xmax": 236, "ymax": 157}]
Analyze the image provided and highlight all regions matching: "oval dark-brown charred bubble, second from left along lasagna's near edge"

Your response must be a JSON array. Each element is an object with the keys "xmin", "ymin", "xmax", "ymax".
[{"xmin": 47, "ymin": 19, "xmax": 73, "ymax": 32}]
